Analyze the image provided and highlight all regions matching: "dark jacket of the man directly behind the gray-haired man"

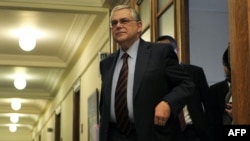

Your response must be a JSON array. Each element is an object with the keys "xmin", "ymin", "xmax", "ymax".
[{"xmin": 181, "ymin": 64, "xmax": 213, "ymax": 141}]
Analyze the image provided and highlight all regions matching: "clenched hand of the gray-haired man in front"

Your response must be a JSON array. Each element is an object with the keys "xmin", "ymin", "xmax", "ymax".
[{"xmin": 154, "ymin": 101, "xmax": 171, "ymax": 126}]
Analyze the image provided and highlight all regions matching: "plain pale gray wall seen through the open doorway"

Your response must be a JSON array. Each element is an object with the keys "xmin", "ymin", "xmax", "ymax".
[{"xmin": 189, "ymin": 0, "xmax": 229, "ymax": 85}]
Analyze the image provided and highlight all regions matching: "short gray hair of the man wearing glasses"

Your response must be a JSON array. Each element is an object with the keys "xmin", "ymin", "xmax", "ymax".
[{"xmin": 110, "ymin": 5, "xmax": 141, "ymax": 21}]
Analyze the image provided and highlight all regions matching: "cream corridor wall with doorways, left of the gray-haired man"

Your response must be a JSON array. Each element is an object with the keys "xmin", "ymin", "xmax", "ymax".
[{"xmin": 31, "ymin": 9, "xmax": 110, "ymax": 141}]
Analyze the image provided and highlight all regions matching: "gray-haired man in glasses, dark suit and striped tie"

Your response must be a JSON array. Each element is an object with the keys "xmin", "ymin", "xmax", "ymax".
[{"xmin": 99, "ymin": 5, "xmax": 194, "ymax": 141}]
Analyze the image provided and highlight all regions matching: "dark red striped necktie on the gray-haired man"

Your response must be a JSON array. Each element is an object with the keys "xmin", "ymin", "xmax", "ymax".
[{"xmin": 115, "ymin": 53, "xmax": 131, "ymax": 135}]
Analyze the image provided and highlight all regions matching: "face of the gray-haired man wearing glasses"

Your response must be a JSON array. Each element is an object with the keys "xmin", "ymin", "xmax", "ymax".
[{"xmin": 111, "ymin": 9, "xmax": 142, "ymax": 44}]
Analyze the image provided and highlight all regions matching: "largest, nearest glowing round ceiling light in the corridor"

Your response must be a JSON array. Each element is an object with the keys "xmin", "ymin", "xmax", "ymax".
[{"xmin": 19, "ymin": 33, "xmax": 36, "ymax": 51}]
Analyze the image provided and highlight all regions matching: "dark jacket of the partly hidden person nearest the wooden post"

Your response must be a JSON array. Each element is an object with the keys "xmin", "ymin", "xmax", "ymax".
[{"xmin": 209, "ymin": 80, "xmax": 229, "ymax": 141}]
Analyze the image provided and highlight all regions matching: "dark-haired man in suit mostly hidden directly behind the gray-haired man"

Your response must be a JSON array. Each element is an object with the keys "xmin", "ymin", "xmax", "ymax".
[{"xmin": 157, "ymin": 35, "xmax": 213, "ymax": 141}]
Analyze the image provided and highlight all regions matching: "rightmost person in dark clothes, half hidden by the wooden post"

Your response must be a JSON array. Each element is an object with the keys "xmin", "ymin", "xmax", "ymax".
[{"xmin": 209, "ymin": 48, "xmax": 232, "ymax": 141}]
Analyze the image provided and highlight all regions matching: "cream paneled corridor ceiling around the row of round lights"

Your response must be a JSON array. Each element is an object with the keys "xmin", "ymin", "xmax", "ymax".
[{"xmin": 0, "ymin": 0, "xmax": 112, "ymax": 131}]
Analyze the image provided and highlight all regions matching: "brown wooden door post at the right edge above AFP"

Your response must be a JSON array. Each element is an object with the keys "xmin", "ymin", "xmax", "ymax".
[{"xmin": 228, "ymin": 0, "xmax": 250, "ymax": 124}]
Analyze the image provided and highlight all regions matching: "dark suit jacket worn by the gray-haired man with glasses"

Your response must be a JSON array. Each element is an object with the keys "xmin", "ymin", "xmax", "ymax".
[{"xmin": 99, "ymin": 39, "xmax": 194, "ymax": 141}]
